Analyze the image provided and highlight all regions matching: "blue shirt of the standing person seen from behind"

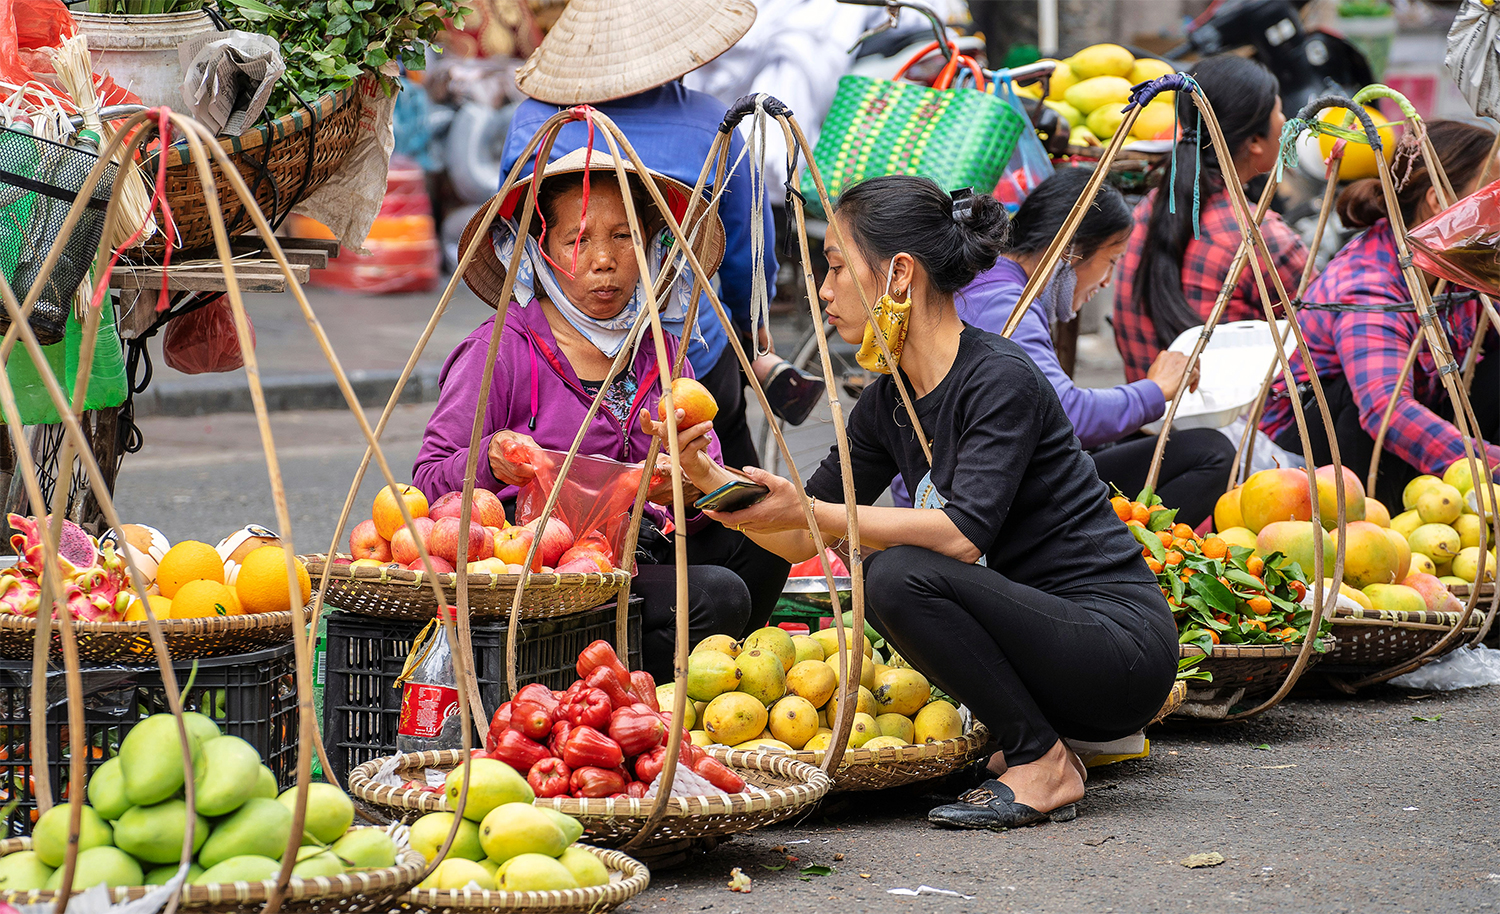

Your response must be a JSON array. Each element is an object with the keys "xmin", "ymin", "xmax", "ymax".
[{"xmin": 500, "ymin": 83, "xmax": 777, "ymax": 377}]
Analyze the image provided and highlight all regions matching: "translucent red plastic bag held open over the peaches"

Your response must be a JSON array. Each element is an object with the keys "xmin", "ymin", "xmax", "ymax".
[{"xmin": 516, "ymin": 446, "xmax": 644, "ymax": 567}]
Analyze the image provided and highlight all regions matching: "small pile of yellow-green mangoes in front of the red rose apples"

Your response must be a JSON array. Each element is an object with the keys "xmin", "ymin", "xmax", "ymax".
[{"xmin": 411, "ymin": 758, "xmax": 609, "ymax": 891}]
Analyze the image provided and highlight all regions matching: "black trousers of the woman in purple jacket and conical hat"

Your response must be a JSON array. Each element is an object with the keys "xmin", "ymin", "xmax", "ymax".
[{"xmin": 630, "ymin": 521, "xmax": 792, "ymax": 683}]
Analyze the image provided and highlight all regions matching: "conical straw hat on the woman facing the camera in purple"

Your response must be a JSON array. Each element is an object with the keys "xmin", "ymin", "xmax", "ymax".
[{"xmin": 459, "ymin": 149, "xmax": 725, "ymax": 309}]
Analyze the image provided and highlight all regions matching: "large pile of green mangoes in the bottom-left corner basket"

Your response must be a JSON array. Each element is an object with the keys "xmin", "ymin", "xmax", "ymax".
[{"xmin": 0, "ymin": 711, "xmax": 396, "ymax": 891}]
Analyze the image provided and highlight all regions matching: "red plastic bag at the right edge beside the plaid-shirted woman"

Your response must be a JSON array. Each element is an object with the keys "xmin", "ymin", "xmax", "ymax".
[{"xmin": 1407, "ymin": 174, "xmax": 1500, "ymax": 296}]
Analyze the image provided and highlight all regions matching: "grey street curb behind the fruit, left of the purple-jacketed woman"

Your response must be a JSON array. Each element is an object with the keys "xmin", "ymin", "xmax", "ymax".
[{"xmin": 135, "ymin": 366, "xmax": 438, "ymax": 419}]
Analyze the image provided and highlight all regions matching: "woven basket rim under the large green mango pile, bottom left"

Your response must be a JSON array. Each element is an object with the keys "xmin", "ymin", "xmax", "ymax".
[{"xmin": 0, "ymin": 837, "xmax": 428, "ymax": 914}]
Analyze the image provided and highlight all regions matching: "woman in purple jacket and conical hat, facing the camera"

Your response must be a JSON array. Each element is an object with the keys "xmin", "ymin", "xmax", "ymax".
[{"xmin": 413, "ymin": 149, "xmax": 789, "ymax": 678}]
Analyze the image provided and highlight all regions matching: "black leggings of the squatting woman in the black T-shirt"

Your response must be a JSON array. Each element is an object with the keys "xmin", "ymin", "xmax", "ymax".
[{"xmin": 866, "ymin": 546, "xmax": 1178, "ymax": 765}]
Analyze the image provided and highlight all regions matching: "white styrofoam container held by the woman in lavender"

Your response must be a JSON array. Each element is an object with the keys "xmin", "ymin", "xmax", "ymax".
[{"xmin": 1142, "ymin": 321, "xmax": 1298, "ymax": 435}]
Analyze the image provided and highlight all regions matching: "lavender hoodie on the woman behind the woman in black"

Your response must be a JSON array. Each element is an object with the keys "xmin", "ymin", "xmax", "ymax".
[{"xmin": 954, "ymin": 257, "xmax": 1167, "ymax": 449}]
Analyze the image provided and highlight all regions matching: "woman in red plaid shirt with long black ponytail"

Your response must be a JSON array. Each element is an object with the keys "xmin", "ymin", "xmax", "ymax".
[{"xmin": 1115, "ymin": 54, "xmax": 1308, "ymax": 381}]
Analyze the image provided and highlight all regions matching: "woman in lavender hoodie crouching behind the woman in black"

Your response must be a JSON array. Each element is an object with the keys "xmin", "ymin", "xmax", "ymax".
[{"xmin": 956, "ymin": 168, "xmax": 1235, "ymax": 527}]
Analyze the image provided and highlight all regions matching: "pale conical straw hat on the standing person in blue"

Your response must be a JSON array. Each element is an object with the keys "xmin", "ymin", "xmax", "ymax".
[{"xmin": 516, "ymin": 0, "xmax": 755, "ymax": 105}]
